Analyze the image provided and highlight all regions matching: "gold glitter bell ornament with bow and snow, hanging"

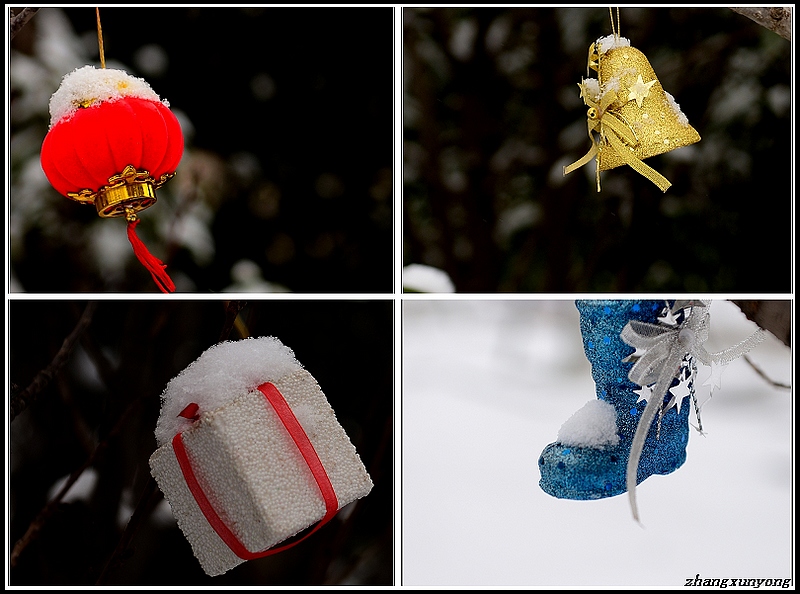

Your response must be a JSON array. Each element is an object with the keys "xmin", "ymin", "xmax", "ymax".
[{"xmin": 564, "ymin": 11, "xmax": 700, "ymax": 192}]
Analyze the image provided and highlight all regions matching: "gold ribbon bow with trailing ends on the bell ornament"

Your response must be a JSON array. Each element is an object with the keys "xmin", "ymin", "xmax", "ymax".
[{"xmin": 564, "ymin": 86, "xmax": 672, "ymax": 192}]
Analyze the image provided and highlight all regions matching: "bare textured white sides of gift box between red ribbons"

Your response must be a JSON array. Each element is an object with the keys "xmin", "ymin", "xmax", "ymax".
[{"xmin": 150, "ymin": 369, "xmax": 372, "ymax": 576}]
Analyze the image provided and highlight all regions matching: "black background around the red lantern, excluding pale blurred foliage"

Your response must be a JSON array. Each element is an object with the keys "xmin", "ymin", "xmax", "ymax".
[{"xmin": 11, "ymin": 7, "xmax": 393, "ymax": 293}]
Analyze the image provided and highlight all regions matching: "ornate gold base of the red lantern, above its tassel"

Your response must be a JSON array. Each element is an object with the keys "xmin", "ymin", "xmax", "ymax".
[{"xmin": 67, "ymin": 165, "xmax": 175, "ymax": 221}]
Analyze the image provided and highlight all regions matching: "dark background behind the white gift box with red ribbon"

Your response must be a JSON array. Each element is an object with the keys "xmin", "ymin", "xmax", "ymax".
[{"xmin": 7, "ymin": 300, "xmax": 394, "ymax": 586}]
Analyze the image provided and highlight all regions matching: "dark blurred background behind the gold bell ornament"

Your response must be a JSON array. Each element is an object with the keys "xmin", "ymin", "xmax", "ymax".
[{"xmin": 403, "ymin": 7, "xmax": 793, "ymax": 292}]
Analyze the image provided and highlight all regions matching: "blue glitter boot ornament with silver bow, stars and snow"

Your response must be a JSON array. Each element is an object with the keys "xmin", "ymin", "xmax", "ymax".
[{"xmin": 539, "ymin": 300, "xmax": 766, "ymax": 521}]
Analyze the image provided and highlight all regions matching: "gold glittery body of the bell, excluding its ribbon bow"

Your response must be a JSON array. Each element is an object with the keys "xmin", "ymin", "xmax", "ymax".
[{"xmin": 597, "ymin": 47, "xmax": 700, "ymax": 171}]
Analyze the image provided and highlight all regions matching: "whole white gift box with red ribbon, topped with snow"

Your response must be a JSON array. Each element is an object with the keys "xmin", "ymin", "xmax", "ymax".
[{"xmin": 150, "ymin": 337, "xmax": 372, "ymax": 576}]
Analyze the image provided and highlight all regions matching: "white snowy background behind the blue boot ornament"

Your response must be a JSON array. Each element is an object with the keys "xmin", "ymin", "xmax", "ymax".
[{"xmin": 402, "ymin": 299, "xmax": 794, "ymax": 587}]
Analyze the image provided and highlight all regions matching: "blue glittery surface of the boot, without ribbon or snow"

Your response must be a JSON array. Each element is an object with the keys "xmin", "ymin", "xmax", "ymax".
[{"xmin": 539, "ymin": 300, "xmax": 690, "ymax": 499}]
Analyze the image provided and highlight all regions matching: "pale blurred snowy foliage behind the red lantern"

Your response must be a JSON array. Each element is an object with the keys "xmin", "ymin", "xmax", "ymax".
[{"xmin": 10, "ymin": 9, "xmax": 214, "ymax": 291}]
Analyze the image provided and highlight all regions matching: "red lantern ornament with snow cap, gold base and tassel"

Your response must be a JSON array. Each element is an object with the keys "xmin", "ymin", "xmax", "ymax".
[{"xmin": 41, "ymin": 66, "xmax": 183, "ymax": 293}]
